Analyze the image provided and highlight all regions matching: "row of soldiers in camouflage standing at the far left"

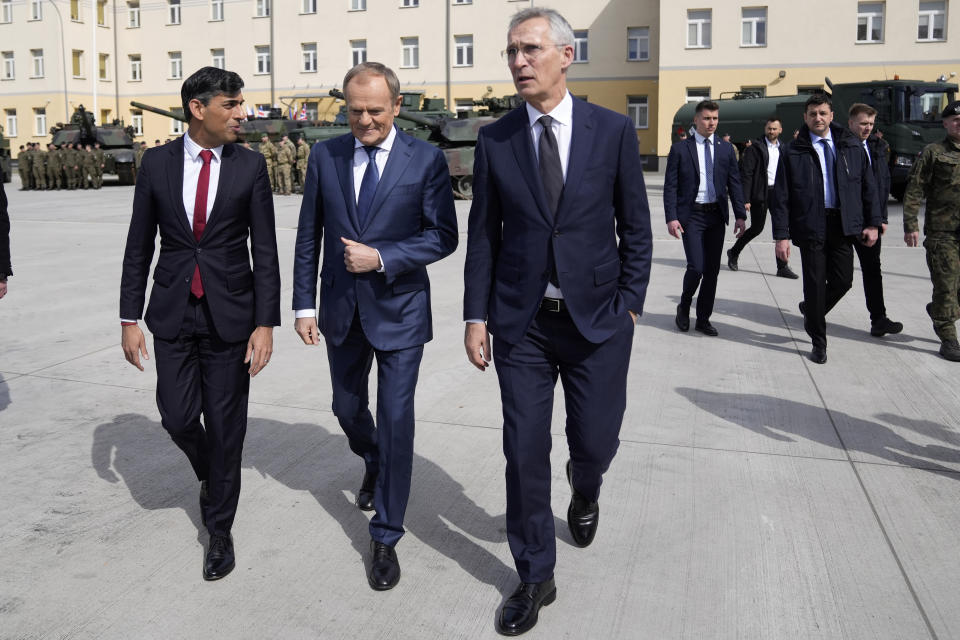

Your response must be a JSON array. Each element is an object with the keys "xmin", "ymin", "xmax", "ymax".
[{"xmin": 17, "ymin": 142, "xmax": 106, "ymax": 191}]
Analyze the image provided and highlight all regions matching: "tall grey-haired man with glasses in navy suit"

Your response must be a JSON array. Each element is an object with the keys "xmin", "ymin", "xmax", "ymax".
[{"xmin": 463, "ymin": 8, "xmax": 652, "ymax": 635}]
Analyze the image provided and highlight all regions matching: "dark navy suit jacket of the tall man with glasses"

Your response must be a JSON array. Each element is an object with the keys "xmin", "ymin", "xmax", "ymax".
[{"xmin": 463, "ymin": 98, "xmax": 653, "ymax": 343}]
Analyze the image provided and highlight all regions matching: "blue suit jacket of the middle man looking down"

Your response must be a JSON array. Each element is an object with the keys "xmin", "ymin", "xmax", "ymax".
[{"xmin": 293, "ymin": 131, "xmax": 458, "ymax": 351}]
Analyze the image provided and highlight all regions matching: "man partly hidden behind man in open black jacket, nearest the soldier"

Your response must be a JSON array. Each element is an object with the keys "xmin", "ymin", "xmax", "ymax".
[{"xmin": 847, "ymin": 102, "xmax": 903, "ymax": 337}]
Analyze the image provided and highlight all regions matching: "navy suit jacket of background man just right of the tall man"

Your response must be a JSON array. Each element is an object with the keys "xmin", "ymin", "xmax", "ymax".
[{"xmin": 663, "ymin": 135, "xmax": 747, "ymax": 226}]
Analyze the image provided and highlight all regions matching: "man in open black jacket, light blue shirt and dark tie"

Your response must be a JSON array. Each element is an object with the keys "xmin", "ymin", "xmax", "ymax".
[{"xmin": 770, "ymin": 93, "xmax": 881, "ymax": 364}]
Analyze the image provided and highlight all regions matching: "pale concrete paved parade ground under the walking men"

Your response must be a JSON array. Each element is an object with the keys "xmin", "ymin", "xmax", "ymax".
[{"xmin": 0, "ymin": 174, "xmax": 960, "ymax": 640}]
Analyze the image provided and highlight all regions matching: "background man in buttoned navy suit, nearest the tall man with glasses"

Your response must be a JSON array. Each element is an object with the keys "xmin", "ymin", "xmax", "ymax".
[{"xmin": 663, "ymin": 100, "xmax": 747, "ymax": 336}]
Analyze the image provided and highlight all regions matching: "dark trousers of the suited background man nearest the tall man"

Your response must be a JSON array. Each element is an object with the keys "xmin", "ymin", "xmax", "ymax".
[{"xmin": 680, "ymin": 211, "xmax": 726, "ymax": 322}]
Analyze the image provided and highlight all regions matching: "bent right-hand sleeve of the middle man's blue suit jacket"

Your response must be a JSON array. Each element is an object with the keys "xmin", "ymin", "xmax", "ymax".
[{"xmin": 374, "ymin": 147, "xmax": 458, "ymax": 284}]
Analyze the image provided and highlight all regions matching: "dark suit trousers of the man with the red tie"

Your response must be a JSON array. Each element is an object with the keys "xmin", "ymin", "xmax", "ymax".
[{"xmin": 153, "ymin": 296, "xmax": 250, "ymax": 535}]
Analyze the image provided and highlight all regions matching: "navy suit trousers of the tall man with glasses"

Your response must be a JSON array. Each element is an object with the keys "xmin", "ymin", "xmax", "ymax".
[{"xmin": 493, "ymin": 310, "xmax": 633, "ymax": 582}]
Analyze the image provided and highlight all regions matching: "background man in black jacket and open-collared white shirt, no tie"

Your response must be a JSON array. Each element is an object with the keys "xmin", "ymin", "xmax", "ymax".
[{"xmin": 727, "ymin": 116, "xmax": 799, "ymax": 280}]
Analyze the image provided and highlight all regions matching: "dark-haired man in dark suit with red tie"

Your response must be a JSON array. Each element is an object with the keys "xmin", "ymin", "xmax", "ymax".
[{"xmin": 120, "ymin": 67, "xmax": 280, "ymax": 580}]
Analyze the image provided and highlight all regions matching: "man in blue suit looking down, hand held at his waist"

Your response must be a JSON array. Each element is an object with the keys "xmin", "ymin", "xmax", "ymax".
[{"xmin": 293, "ymin": 62, "xmax": 457, "ymax": 591}]
